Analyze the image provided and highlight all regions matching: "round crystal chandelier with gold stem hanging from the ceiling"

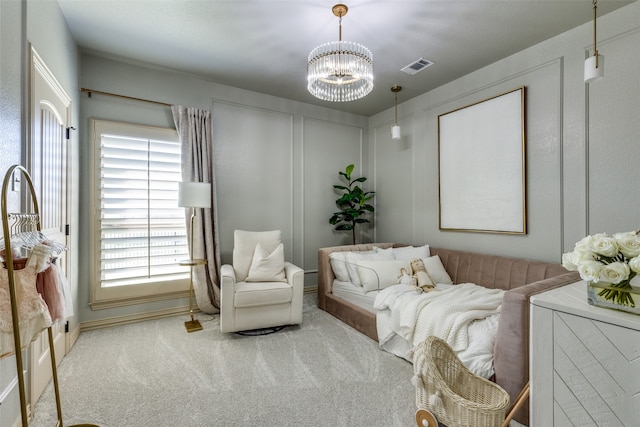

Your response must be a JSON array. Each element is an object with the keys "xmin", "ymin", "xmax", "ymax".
[{"xmin": 307, "ymin": 4, "xmax": 373, "ymax": 102}]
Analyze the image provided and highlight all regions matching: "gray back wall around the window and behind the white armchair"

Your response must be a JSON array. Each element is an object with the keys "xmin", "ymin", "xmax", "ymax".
[{"xmin": 79, "ymin": 54, "xmax": 371, "ymax": 322}]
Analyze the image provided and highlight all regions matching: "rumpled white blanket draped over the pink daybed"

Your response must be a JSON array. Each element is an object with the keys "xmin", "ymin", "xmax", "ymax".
[{"xmin": 374, "ymin": 283, "xmax": 504, "ymax": 378}]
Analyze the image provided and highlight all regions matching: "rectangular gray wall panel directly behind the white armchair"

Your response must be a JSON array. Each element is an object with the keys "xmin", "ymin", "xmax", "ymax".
[{"xmin": 211, "ymin": 98, "xmax": 299, "ymax": 262}]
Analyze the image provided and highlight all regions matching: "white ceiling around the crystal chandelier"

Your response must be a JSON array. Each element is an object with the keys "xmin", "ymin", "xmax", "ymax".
[{"xmin": 58, "ymin": 0, "xmax": 632, "ymax": 116}]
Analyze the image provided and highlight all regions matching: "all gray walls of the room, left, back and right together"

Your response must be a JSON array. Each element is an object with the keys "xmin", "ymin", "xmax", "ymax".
[{"xmin": 0, "ymin": 5, "xmax": 640, "ymax": 425}]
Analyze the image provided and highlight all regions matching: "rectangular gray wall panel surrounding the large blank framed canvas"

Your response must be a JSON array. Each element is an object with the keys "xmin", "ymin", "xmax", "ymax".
[{"xmin": 396, "ymin": 55, "xmax": 565, "ymax": 262}]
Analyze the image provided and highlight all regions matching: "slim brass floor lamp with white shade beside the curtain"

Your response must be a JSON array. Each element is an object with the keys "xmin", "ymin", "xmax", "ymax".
[{"xmin": 178, "ymin": 182, "xmax": 211, "ymax": 332}]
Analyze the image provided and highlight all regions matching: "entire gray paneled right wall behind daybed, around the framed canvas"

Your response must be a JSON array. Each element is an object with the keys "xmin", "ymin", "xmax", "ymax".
[{"xmin": 369, "ymin": 2, "xmax": 640, "ymax": 262}]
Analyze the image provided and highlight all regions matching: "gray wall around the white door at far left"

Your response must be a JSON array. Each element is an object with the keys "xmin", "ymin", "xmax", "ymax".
[{"xmin": 0, "ymin": 0, "xmax": 79, "ymax": 426}]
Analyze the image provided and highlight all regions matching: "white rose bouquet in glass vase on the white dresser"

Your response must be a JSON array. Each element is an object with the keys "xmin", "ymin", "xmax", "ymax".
[{"xmin": 562, "ymin": 230, "xmax": 640, "ymax": 307}]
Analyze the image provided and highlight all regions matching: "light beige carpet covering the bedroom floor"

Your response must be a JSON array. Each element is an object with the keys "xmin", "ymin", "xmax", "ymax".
[{"xmin": 30, "ymin": 295, "xmax": 415, "ymax": 427}]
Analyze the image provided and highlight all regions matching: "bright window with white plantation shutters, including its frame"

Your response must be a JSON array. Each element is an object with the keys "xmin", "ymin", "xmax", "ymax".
[{"xmin": 91, "ymin": 120, "xmax": 189, "ymax": 308}]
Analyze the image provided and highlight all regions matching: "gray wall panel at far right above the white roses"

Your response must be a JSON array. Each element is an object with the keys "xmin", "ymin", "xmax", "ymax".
[{"xmin": 584, "ymin": 26, "xmax": 640, "ymax": 234}]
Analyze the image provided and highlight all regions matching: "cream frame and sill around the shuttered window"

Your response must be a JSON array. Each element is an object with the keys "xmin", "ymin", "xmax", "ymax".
[{"xmin": 89, "ymin": 119, "xmax": 189, "ymax": 310}]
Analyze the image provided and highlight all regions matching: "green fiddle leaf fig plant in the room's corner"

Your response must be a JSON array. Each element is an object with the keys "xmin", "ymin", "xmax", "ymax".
[{"xmin": 329, "ymin": 164, "xmax": 375, "ymax": 245}]
